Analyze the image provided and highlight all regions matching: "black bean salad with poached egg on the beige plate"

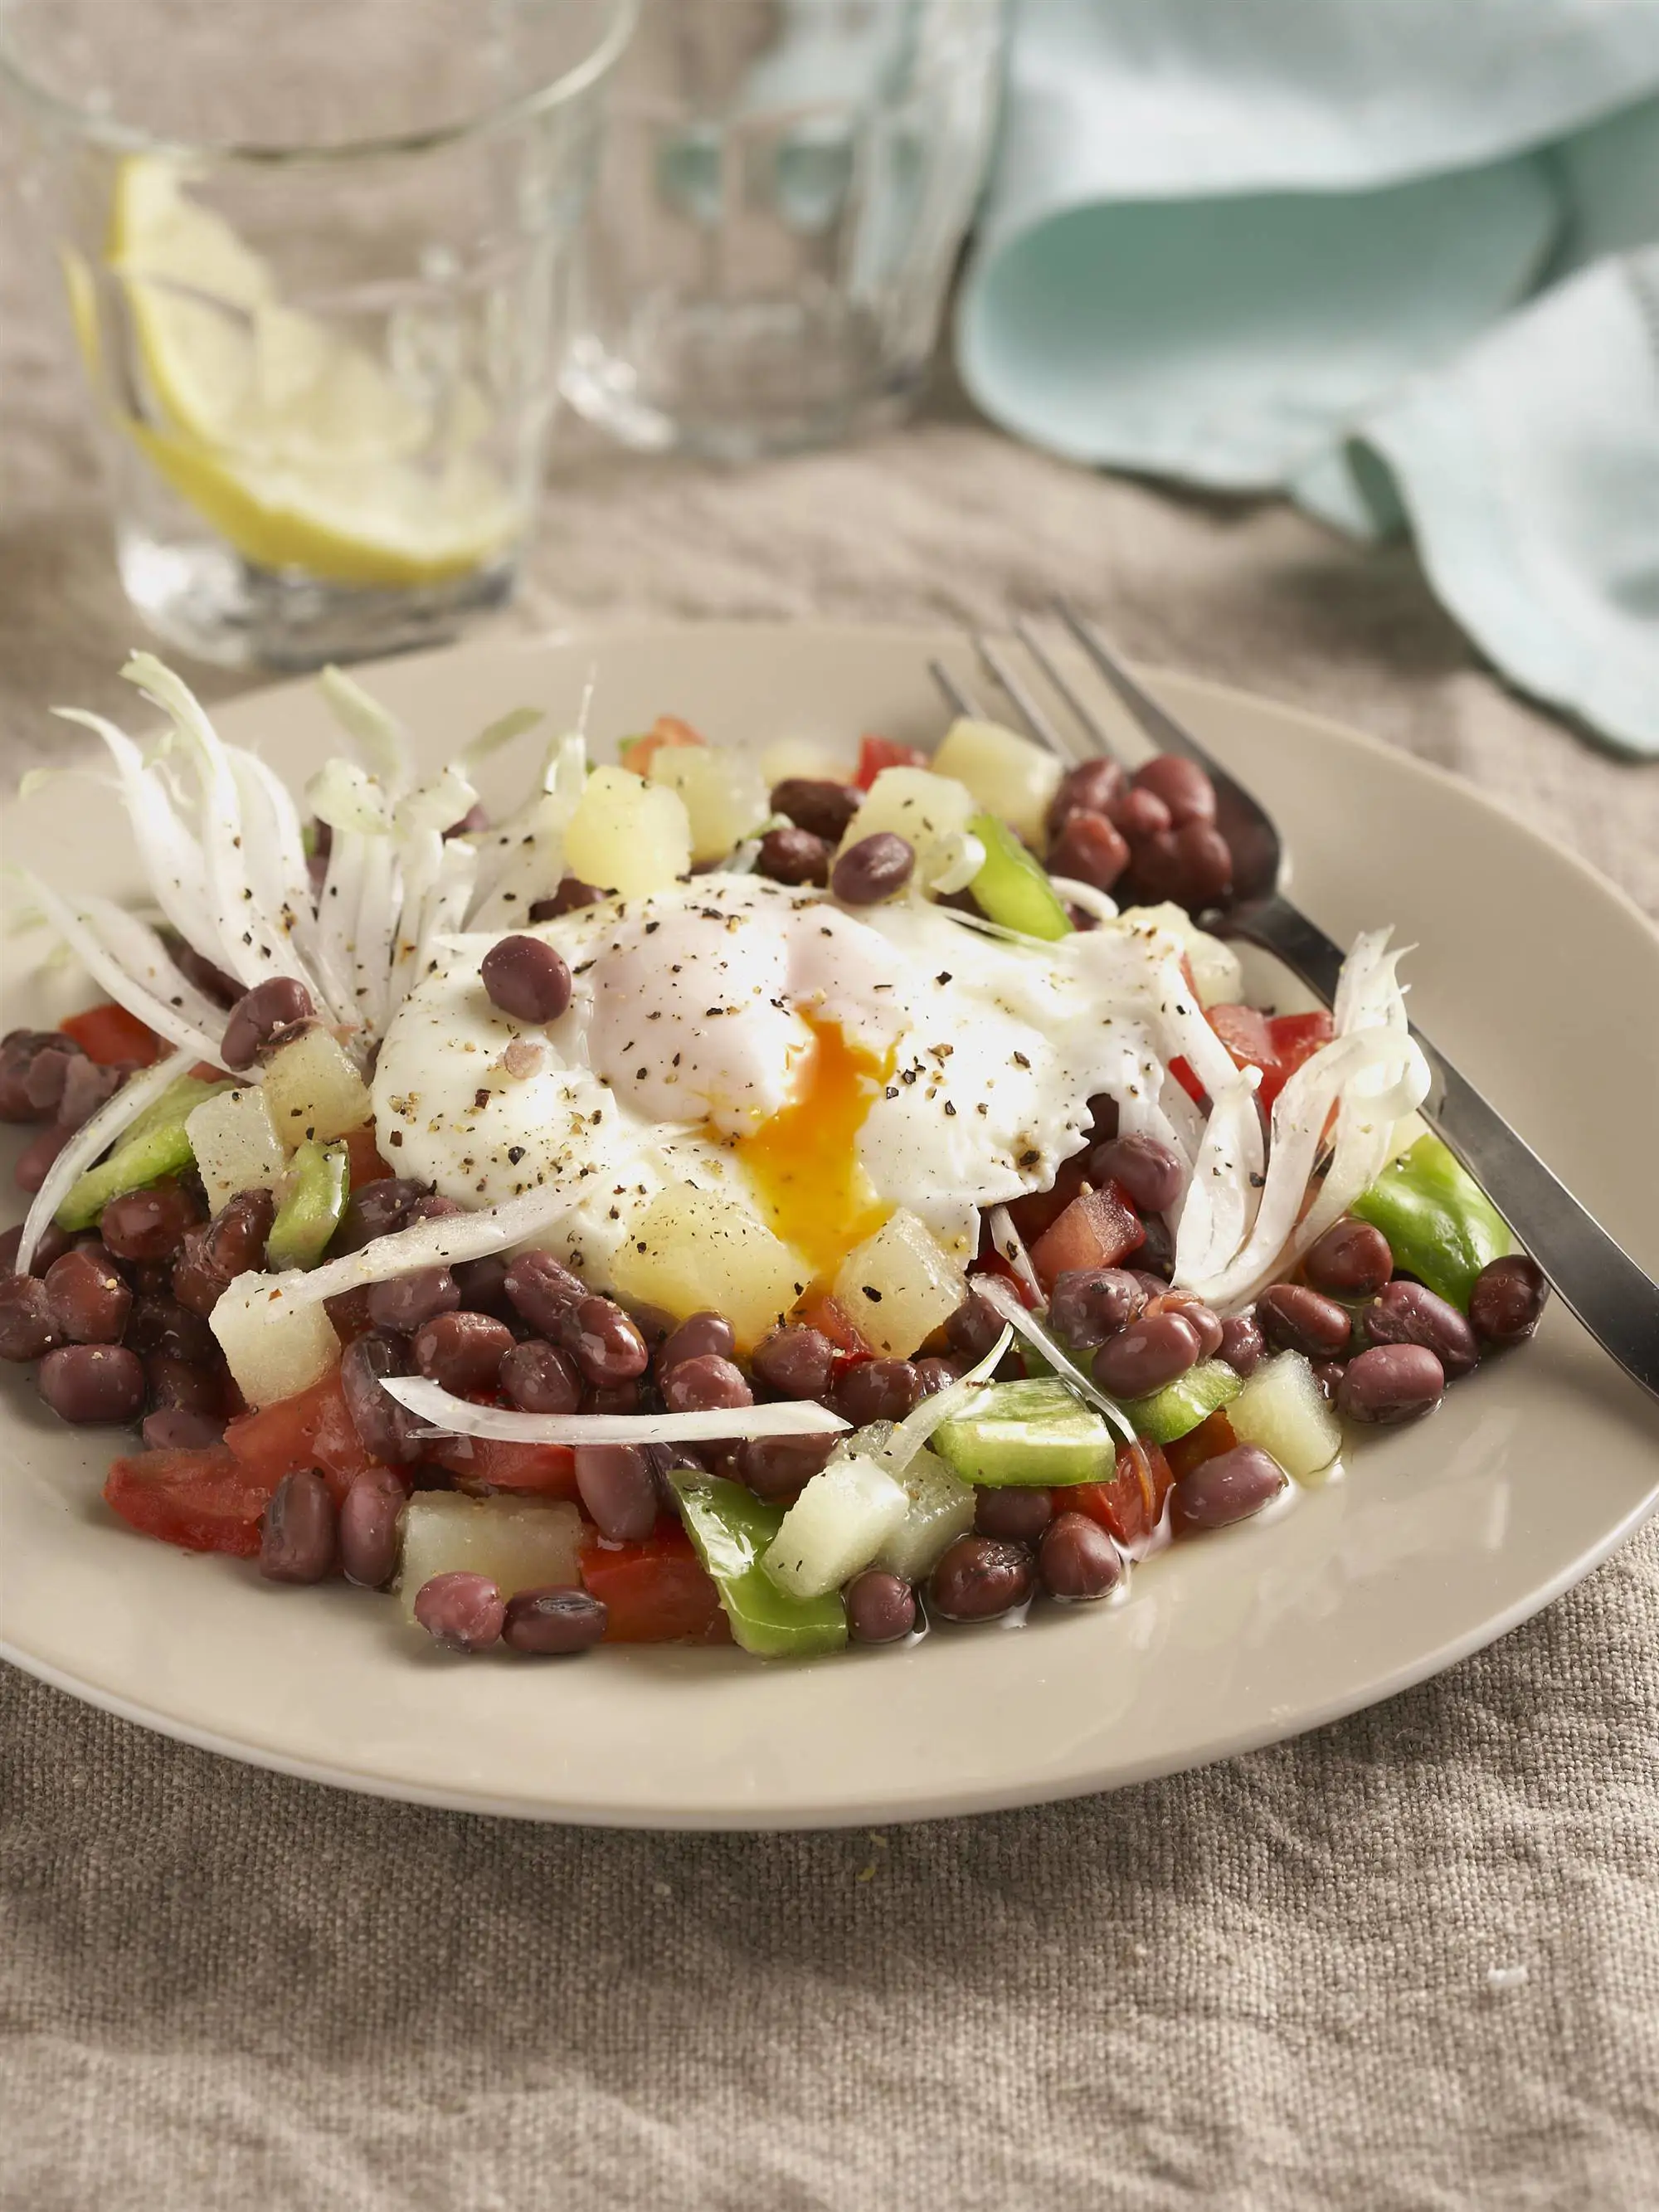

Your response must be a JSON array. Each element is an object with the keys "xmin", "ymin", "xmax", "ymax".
[{"xmin": 0, "ymin": 655, "xmax": 1544, "ymax": 1657}]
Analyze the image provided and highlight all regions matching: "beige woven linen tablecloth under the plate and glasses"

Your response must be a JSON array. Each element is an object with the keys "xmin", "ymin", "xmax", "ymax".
[{"xmin": 0, "ymin": 241, "xmax": 1659, "ymax": 2212}]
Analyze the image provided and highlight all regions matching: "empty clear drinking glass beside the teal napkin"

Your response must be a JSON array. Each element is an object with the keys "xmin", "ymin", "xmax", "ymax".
[{"xmin": 564, "ymin": 0, "xmax": 1005, "ymax": 460}]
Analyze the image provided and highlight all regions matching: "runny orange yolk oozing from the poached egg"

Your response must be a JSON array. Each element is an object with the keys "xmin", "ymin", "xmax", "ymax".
[{"xmin": 737, "ymin": 1017, "xmax": 892, "ymax": 1276}]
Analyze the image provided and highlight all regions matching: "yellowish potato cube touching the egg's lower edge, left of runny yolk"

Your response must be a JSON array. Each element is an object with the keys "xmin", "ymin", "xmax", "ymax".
[{"xmin": 611, "ymin": 1183, "xmax": 814, "ymax": 1349}]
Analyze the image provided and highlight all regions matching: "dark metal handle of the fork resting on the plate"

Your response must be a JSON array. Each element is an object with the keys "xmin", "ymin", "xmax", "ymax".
[{"xmin": 1225, "ymin": 898, "xmax": 1659, "ymax": 1396}]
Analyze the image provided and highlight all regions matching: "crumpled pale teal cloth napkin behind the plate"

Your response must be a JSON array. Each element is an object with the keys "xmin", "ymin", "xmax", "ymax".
[{"xmin": 956, "ymin": 0, "xmax": 1659, "ymax": 754}]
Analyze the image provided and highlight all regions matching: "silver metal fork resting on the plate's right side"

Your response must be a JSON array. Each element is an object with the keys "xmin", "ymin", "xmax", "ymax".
[{"xmin": 933, "ymin": 599, "xmax": 1659, "ymax": 1396}]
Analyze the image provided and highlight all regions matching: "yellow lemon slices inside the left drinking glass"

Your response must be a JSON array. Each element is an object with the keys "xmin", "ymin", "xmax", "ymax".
[{"xmin": 106, "ymin": 155, "xmax": 524, "ymax": 591}]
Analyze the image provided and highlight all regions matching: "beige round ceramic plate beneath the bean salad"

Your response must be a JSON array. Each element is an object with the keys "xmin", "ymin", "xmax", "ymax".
[{"xmin": 0, "ymin": 624, "xmax": 1659, "ymax": 1827}]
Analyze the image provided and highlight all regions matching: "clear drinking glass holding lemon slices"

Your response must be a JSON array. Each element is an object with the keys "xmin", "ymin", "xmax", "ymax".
[{"xmin": 0, "ymin": 0, "xmax": 635, "ymax": 668}]
